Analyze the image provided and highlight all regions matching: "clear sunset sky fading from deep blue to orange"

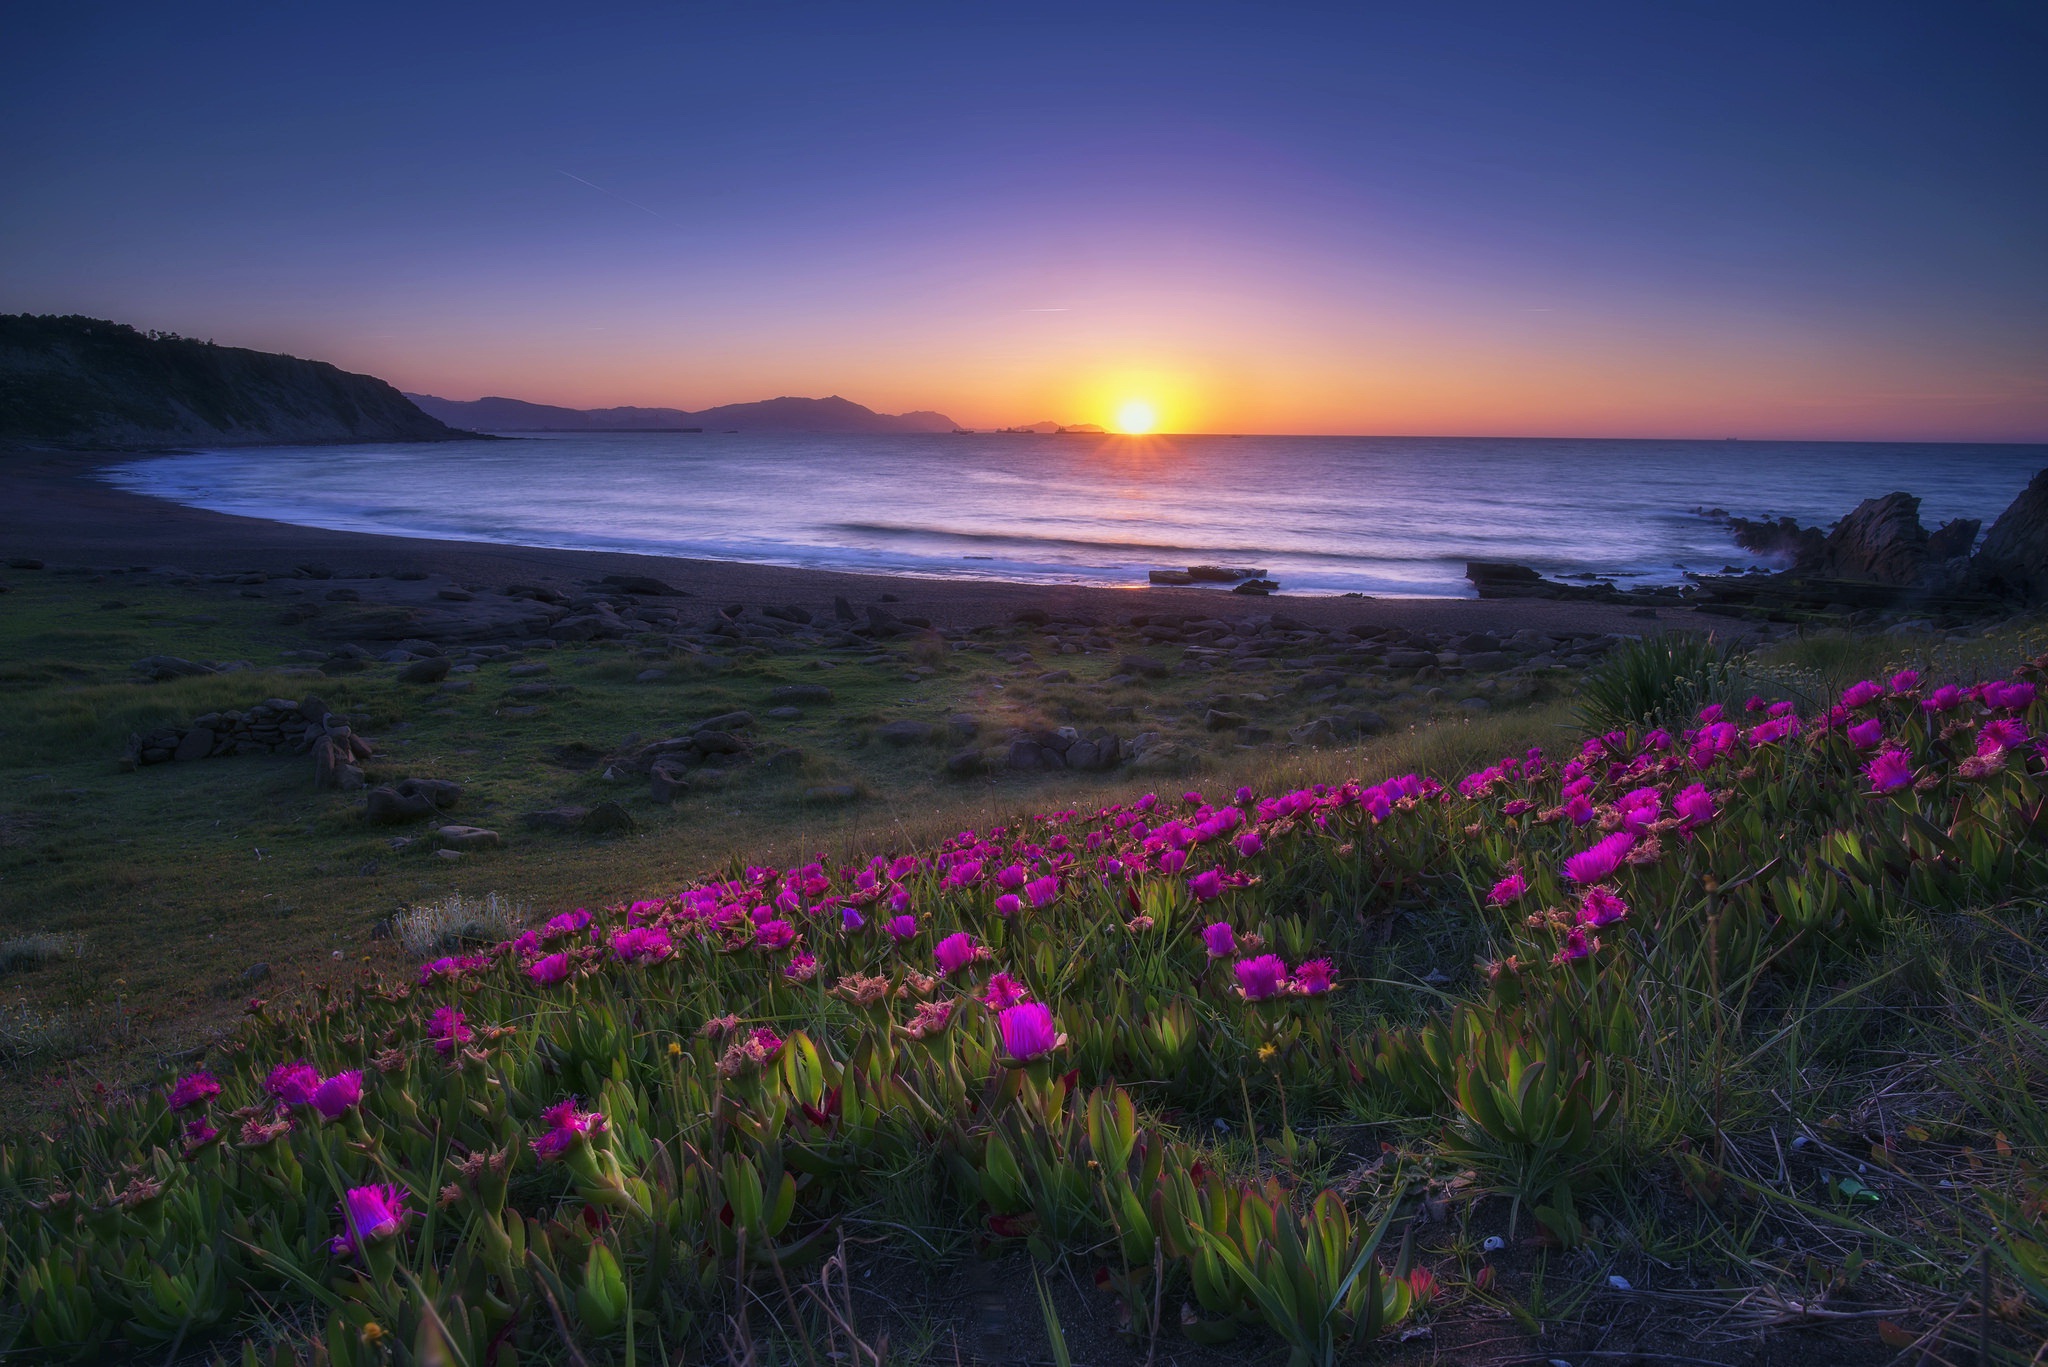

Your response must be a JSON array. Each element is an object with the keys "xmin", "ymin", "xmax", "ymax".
[{"xmin": 0, "ymin": 0, "xmax": 2048, "ymax": 441}]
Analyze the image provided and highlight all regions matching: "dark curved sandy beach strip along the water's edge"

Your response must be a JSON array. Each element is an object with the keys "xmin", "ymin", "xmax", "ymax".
[{"xmin": 0, "ymin": 447, "xmax": 1745, "ymax": 635}]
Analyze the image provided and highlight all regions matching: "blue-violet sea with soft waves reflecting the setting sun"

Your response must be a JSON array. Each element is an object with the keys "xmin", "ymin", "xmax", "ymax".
[{"xmin": 104, "ymin": 432, "xmax": 2048, "ymax": 598}]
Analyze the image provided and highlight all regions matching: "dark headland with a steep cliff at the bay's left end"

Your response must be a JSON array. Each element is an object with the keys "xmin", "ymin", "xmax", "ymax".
[{"xmin": 0, "ymin": 314, "xmax": 467, "ymax": 447}]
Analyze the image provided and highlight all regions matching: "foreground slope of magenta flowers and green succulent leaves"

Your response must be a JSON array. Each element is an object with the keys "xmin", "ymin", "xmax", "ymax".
[{"xmin": 0, "ymin": 635, "xmax": 2048, "ymax": 1365}]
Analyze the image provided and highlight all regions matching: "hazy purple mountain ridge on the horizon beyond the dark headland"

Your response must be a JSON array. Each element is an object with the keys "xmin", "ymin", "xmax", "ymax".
[{"xmin": 406, "ymin": 393, "xmax": 954, "ymax": 432}]
